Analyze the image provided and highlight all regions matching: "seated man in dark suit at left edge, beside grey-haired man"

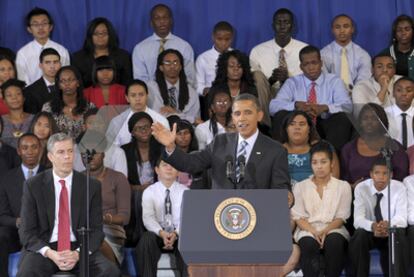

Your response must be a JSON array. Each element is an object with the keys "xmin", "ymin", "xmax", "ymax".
[{"xmin": 0, "ymin": 133, "xmax": 43, "ymax": 276}]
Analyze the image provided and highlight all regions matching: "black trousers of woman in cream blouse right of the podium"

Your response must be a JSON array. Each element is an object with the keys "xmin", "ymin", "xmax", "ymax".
[{"xmin": 299, "ymin": 233, "xmax": 347, "ymax": 277}]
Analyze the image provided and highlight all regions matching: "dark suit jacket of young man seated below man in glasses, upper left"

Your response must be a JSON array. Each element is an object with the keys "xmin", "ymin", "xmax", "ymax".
[{"xmin": 23, "ymin": 77, "xmax": 56, "ymax": 114}]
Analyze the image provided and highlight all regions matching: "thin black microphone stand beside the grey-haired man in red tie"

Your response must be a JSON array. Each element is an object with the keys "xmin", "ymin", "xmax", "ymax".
[{"xmin": 78, "ymin": 149, "xmax": 96, "ymax": 277}]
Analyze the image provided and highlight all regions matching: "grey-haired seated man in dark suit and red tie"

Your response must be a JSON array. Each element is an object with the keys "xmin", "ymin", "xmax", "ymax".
[{"xmin": 17, "ymin": 133, "xmax": 120, "ymax": 277}]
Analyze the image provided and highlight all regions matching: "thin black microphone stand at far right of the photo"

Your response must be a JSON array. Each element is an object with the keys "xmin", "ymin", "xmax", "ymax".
[{"xmin": 380, "ymin": 146, "xmax": 397, "ymax": 277}]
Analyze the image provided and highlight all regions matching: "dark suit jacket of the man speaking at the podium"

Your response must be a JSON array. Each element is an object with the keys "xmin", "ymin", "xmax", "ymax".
[{"xmin": 164, "ymin": 132, "xmax": 290, "ymax": 190}]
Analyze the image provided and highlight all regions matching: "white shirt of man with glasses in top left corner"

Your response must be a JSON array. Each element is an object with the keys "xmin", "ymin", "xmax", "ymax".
[{"xmin": 16, "ymin": 39, "xmax": 70, "ymax": 86}]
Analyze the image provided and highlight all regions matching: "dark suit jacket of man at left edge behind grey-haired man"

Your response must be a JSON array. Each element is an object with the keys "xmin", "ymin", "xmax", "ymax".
[{"xmin": 0, "ymin": 166, "xmax": 44, "ymax": 227}]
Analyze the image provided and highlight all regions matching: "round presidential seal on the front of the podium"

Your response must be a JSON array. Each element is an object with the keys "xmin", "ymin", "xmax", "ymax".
[{"xmin": 214, "ymin": 197, "xmax": 256, "ymax": 240}]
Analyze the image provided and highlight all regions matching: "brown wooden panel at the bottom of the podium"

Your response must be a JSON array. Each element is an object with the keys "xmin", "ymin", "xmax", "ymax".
[{"xmin": 188, "ymin": 264, "xmax": 283, "ymax": 277}]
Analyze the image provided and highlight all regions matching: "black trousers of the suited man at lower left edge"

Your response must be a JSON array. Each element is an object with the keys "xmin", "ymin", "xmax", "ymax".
[{"xmin": 0, "ymin": 226, "xmax": 21, "ymax": 277}]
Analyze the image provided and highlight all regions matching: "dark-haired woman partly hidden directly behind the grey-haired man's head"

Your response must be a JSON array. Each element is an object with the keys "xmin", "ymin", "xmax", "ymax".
[{"xmin": 29, "ymin": 112, "xmax": 59, "ymax": 168}]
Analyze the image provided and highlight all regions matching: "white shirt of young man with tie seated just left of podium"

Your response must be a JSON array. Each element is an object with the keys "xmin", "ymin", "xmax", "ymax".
[{"xmin": 142, "ymin": 181, "xmax": 188, "ymax": 235}]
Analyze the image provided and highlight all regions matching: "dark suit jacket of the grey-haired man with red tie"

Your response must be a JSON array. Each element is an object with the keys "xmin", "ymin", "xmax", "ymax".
[{"xmin": 19, "ymin": 169, "xmax": 104, "ymax": 252}]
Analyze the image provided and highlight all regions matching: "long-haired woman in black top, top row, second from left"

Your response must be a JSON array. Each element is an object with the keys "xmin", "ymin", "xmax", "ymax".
[{"xmin": 72, "ymin": 17, "xmax": 132, "ymax": 87}]
